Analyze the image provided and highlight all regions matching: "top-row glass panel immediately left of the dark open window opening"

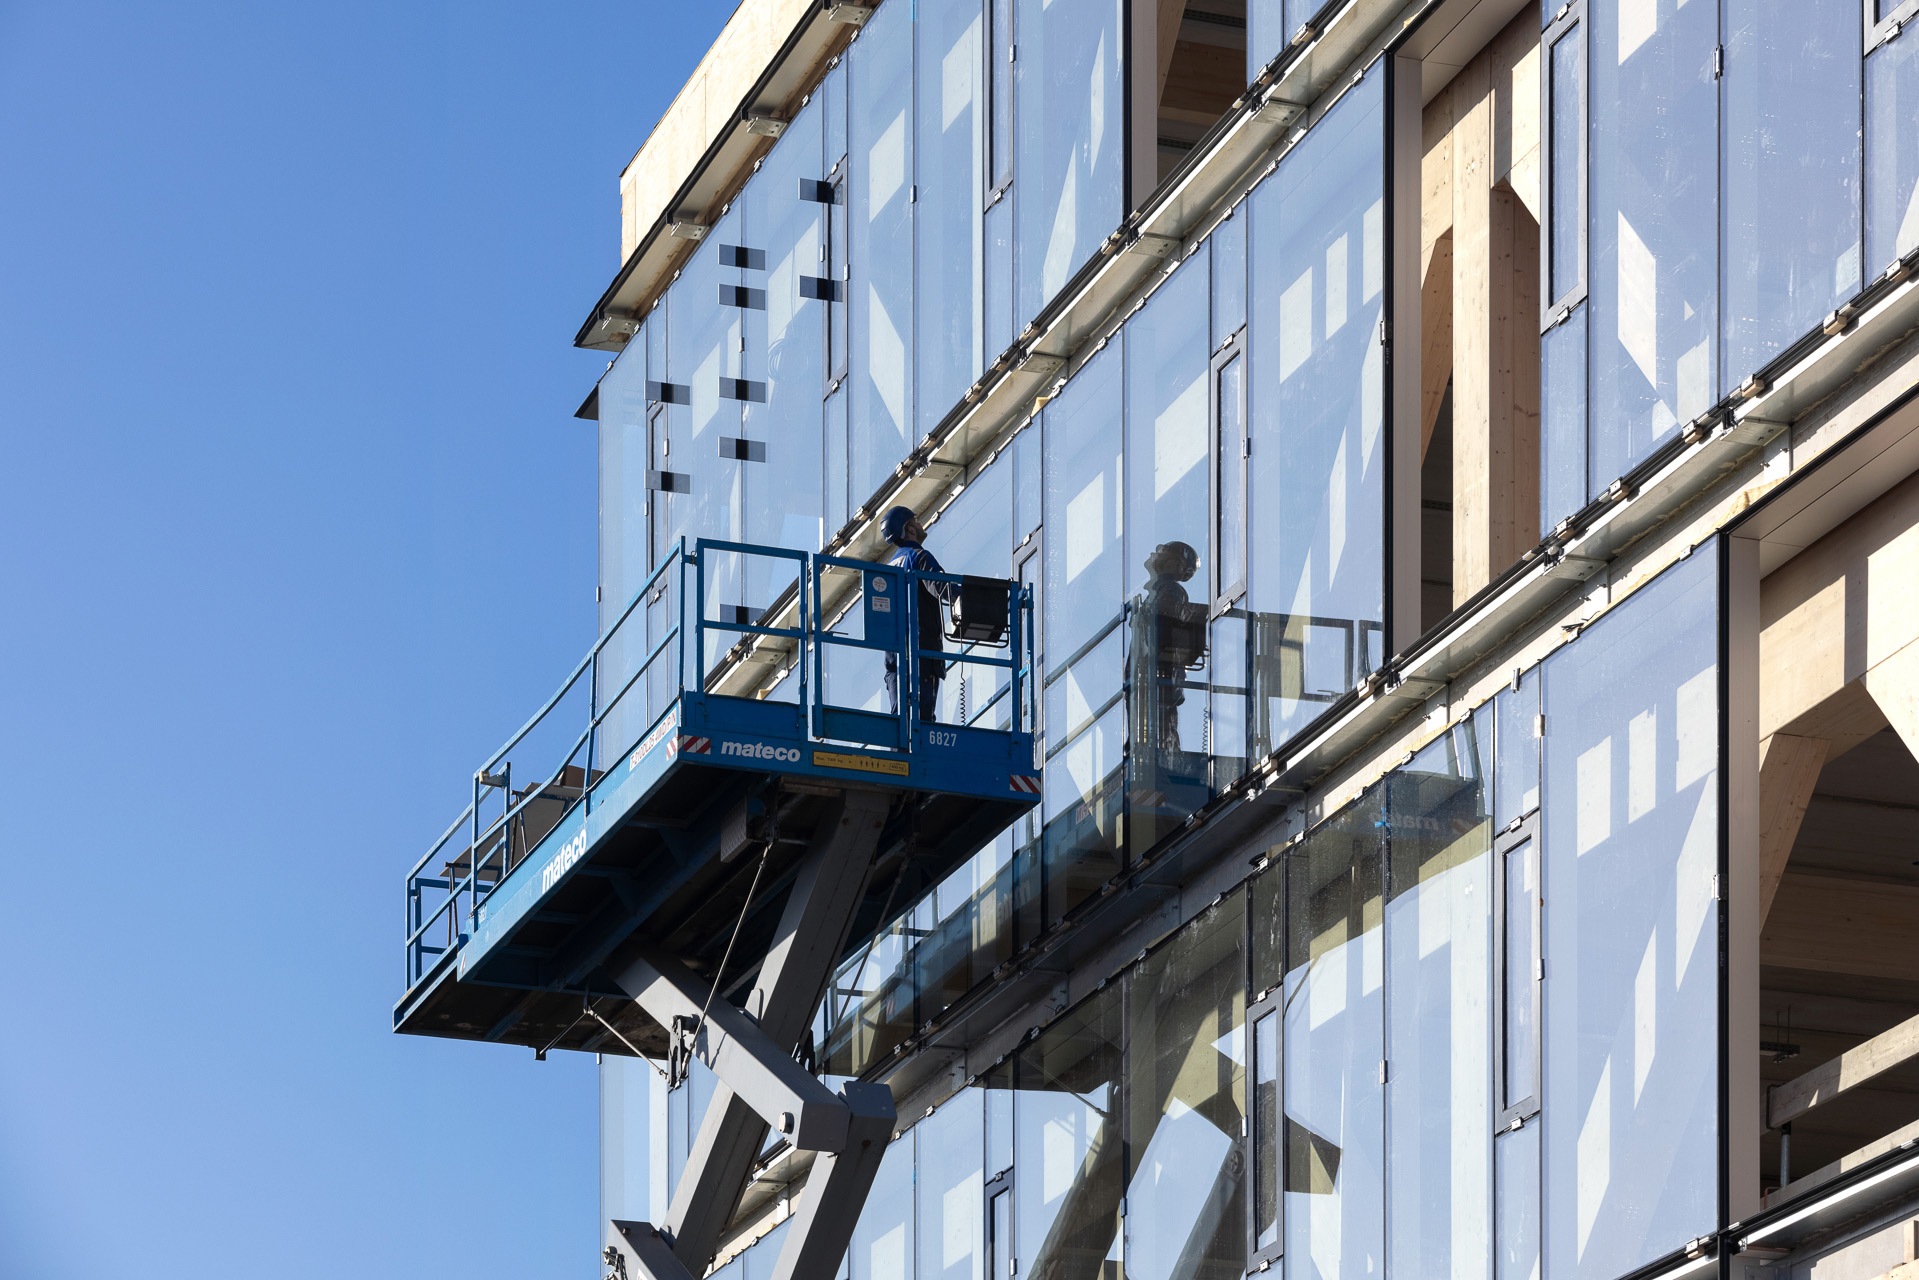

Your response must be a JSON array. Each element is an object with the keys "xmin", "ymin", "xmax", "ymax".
[{"xmin": 1013, "ymin": 0, "xmax": 1125, "ymax": 326}]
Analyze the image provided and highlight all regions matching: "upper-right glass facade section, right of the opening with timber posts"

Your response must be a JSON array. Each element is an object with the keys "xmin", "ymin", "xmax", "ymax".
[{"xmin": 1541, "ymin": 0, "xmax": 1919, "ymax": 530}]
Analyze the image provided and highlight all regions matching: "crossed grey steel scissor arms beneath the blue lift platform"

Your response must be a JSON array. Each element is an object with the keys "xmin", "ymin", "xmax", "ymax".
[{"xmin": 606, "ymin": 789, "xmax": 894, "ymax": 1280}]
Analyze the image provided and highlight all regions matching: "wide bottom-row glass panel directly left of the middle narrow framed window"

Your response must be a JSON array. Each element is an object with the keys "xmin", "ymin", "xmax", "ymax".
[{"xmin": 1125, "ymin": 894, "xmax": 1245, "ymax": 1280}]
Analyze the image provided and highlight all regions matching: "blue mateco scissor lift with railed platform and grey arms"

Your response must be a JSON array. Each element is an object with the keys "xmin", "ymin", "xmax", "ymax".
[{"xmin": 393, "ymin": 539, "xmax": 1040, "ymax": 1280}]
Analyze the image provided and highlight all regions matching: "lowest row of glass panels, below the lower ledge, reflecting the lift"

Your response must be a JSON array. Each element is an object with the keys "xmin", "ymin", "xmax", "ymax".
[{"xmin": 621, "ymin": 553, "xmax": 1721, "ymax": 1280}]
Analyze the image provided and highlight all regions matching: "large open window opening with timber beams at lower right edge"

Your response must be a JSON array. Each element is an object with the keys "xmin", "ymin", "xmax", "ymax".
[{"xmin": 1744, "ymin": 462, "xmax": 1919, "ymax": 1212}]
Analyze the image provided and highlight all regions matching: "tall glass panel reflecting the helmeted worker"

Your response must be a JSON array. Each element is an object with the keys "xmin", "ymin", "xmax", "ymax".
[{"xmin": 1125, "ymin": 259, "xmax": 1211, "ymax": 846}]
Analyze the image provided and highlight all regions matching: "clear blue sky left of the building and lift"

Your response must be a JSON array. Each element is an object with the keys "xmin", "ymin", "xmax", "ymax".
[{"xmin": 0, "ymin": 0, "xmax": 731, "ymax": 1280}]
